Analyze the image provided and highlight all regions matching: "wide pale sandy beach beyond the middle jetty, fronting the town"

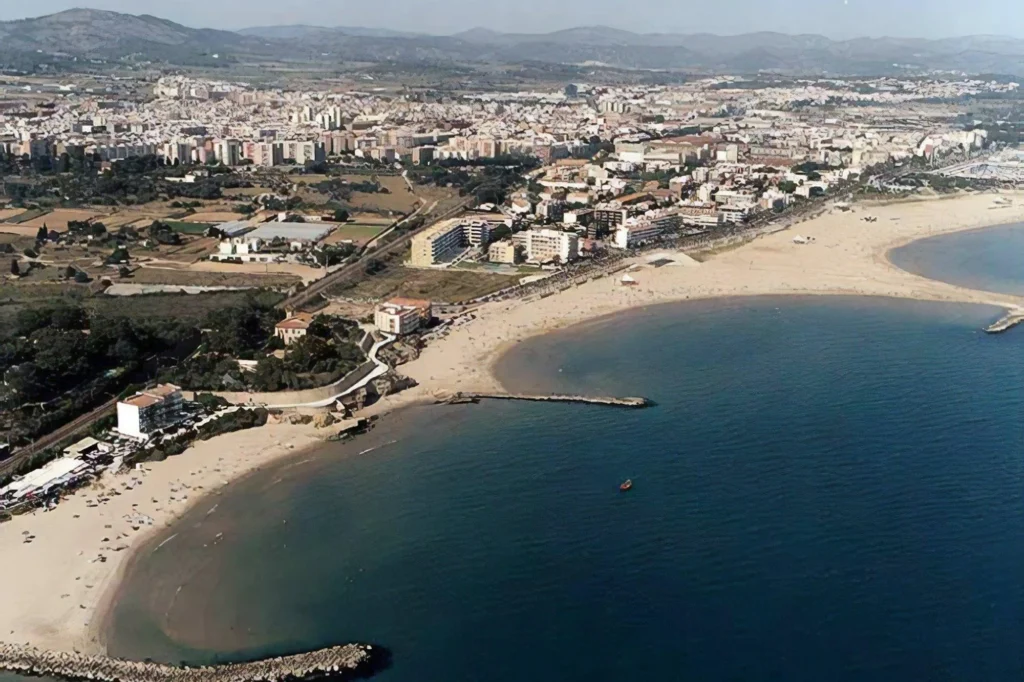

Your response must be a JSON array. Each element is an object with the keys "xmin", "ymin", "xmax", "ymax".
[{"xmin": 396, "ymin": 188, "xmax": 1024, "ymax": 399}]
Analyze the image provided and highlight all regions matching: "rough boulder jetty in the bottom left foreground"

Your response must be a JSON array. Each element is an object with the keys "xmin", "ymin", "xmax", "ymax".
[{"xmin": 0, "ymin": 644, "xmax": 388, "ymax": 682}]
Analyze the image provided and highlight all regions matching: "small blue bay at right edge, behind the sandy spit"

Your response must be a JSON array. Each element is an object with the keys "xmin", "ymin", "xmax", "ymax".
[{"xmin": 889, "ymin": 223, "xmax": 1024, "ymax": 296}]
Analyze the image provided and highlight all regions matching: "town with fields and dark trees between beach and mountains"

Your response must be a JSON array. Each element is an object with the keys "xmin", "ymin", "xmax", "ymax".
[{"xmin": 0, "ymin": 10, "xmax": 1024, "ymax": 515}]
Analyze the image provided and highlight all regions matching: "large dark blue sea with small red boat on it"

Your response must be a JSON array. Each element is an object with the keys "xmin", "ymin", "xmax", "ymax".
[{"xmin": 2, "ymin": 228, "xmax": 1024, "ymax": 682}]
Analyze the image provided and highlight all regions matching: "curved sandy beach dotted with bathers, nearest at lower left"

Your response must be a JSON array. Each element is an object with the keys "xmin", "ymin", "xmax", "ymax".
[{"xmin": 0, "ymin": 423, "xmax": 322, "ymax": 653}]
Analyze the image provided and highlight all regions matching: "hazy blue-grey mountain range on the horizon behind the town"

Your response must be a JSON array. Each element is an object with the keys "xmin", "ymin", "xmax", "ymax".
[{"xmin": 6, "ymin": 9, "xmax": 1024, "ymax": 75}]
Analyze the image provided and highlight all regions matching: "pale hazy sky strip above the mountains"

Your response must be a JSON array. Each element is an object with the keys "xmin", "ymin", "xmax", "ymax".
[{"xmin": 0, "ymin": 0, "xmax": 1024, "ymax": 38}]
